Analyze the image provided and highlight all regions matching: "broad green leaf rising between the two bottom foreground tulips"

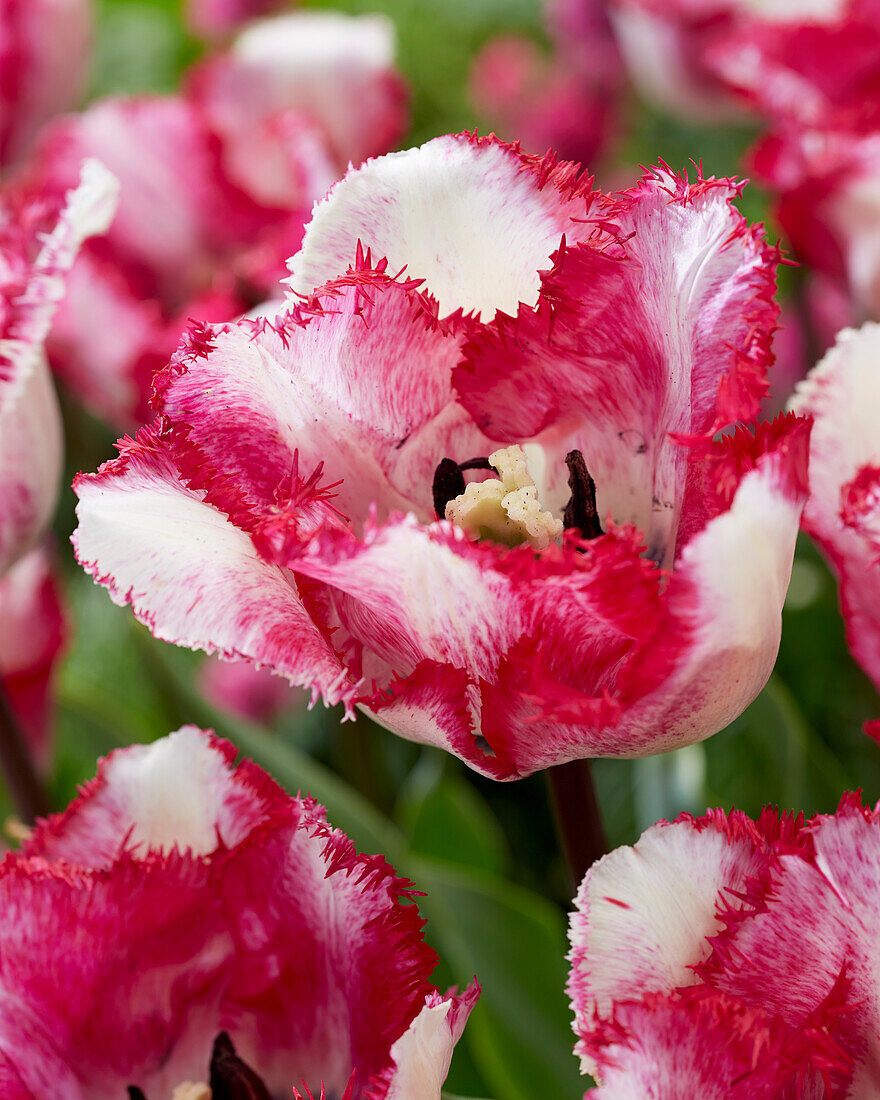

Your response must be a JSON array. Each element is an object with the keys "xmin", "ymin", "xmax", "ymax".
[{"xmin": 407, "ymin": 858, "xmax": 585, "ymax": 1100}]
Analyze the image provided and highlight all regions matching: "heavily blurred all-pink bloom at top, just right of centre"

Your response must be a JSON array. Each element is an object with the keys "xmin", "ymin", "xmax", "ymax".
[{"xmin": 471, "ymin": 2, "xmax": 623, "ymax": 165}]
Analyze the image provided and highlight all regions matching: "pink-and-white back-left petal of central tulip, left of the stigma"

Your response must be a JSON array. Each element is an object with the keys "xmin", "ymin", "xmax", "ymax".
[{"xmin": 154, "ymin": 264, "xmax": 487, "ymax": 526}]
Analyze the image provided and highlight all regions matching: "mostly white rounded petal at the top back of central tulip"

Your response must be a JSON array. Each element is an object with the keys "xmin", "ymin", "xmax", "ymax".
[{"xmin": 289, "ymin": 134, "xmax": 592, "ymax": 320}]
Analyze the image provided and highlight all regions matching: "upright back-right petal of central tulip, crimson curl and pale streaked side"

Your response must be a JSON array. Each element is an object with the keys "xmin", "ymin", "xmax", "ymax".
[{"xmin": 455, "ymin": 168, "xmax": 778, "ymax": 563}]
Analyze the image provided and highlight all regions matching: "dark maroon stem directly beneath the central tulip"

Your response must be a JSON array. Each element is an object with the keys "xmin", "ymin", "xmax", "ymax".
[{"xmin": 545, "ymin": 760, "xmax": 608, "ymax": 891}]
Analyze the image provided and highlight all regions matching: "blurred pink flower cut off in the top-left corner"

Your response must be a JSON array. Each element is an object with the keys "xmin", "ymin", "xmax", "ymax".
[{"xmin": 0, "ymin": 0, "xmax": 91, "ymax": 167}]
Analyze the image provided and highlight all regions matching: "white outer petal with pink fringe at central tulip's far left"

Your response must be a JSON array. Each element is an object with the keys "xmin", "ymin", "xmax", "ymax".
[{"xmin": 73, "ymin": 430, "xmax": 354, "ymax": 703}]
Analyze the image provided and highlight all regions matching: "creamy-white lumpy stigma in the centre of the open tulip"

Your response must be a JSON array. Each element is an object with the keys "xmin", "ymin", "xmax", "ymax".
[{"xmin": 446, "ymin": 444, "xmax": 563, "ymax": 550}]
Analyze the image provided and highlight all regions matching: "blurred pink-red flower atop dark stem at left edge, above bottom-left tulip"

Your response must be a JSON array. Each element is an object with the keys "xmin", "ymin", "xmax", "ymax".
[{"xmin": 0, "ymin": 547, "xmax": 66, "ymax": 768}]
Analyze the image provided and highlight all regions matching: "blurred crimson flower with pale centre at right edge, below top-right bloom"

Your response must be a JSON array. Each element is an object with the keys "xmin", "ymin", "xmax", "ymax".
[{"xmin": 752, "ymin": 127, "xmax": 880, "ymax": 323}]
